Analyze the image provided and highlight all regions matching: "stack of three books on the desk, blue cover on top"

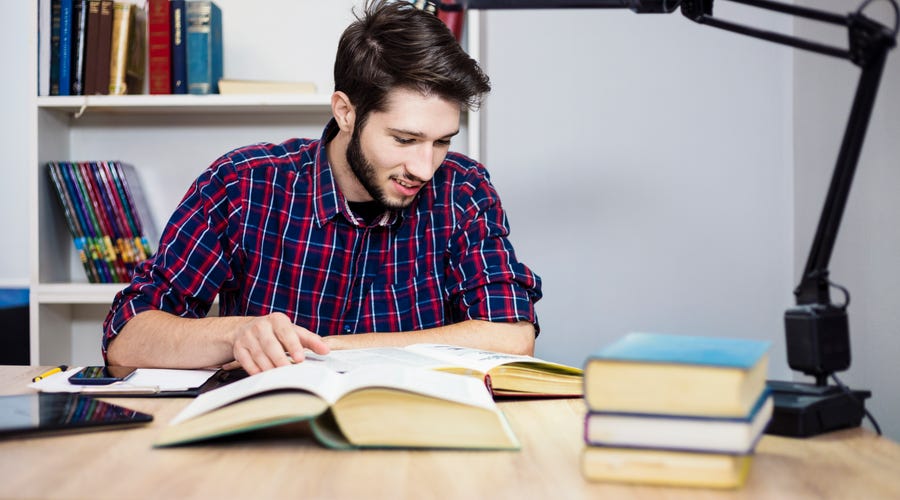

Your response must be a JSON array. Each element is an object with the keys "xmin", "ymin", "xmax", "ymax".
[{"xmin": 581, "ymin": 333, "xmax": 773, "ymax": 488}]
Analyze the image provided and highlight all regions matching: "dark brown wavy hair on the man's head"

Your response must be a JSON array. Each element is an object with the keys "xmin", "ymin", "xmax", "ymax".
[{"xmin": 334, "ymin": 0, "xmax": 491, "ymax": 127}]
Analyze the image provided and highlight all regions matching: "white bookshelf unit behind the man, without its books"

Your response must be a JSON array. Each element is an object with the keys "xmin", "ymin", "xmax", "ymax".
[{"xmin": 27, "ymin": 0, "xmax": 481, "ymax": 365}]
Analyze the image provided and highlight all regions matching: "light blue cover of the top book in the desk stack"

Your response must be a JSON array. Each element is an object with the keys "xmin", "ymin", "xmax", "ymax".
[{"xmin": 591, "ymin": 333, "xmax": 771, "ymax": 369}]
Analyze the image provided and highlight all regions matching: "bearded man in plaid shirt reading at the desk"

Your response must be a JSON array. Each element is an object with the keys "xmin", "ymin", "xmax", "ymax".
[{"xmin": 103, "ymin": 2, "xmax": 541, "ymax": 374}]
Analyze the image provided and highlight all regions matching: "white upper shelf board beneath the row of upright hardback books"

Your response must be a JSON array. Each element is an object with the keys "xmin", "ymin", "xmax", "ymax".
[{"xmin": 37, "ymin": 94, "xmax": 331, "ymax": 117}]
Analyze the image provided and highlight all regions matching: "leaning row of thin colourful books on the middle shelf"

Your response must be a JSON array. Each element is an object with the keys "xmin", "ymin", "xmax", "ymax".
[{"xmin": 47, "ymin": 161, "xmax": 153, "ymax": 283}]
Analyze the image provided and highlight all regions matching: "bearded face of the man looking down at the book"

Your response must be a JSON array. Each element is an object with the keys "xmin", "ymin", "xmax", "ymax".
[{"xmin": 347, "ymin": 89, "xmax": 460, "ymax": 208}]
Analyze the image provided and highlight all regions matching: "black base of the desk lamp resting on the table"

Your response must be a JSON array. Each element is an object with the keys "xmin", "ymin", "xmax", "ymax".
[{"xmin": 766, "ymin": 380, "xmax": 872, "ymax": 437}]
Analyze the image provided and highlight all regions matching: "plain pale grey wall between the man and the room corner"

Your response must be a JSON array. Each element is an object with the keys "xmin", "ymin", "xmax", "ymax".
[{"xmin": 485, "ymin": 6, "xmax": 793, "ymax": 368}]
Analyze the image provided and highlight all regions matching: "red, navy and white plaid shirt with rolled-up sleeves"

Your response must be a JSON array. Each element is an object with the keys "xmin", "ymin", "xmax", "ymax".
[{"xmin": 103, "ymin": 122, "xmax": 541, "ymax": 354}]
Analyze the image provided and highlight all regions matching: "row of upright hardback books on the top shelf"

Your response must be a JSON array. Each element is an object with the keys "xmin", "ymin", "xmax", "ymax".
[{"xmin": 38, "ymin": 0, "xmax": 223, "ymax": 96}]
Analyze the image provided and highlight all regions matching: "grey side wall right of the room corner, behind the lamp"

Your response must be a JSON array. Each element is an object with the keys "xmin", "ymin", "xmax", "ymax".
[{"xmin": 794, "ymin": 0, "xmax": 900, "ymax": 440}]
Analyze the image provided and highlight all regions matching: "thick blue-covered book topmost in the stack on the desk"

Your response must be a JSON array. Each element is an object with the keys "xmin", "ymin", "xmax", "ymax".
[{"xmin": 584, "ymin": 333, "xmax": 770, "ymax": 417}]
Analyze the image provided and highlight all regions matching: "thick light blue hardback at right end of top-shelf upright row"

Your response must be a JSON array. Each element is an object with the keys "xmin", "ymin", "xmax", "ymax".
[{"xmin": 186, "ymin": 1, "xmax": 223, "ymax": 94}]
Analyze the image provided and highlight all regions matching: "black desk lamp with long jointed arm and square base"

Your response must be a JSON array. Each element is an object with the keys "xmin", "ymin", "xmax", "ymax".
[{"xmin": 426, "ymin": 0, "xmax": 900, "ymax": 436}]
